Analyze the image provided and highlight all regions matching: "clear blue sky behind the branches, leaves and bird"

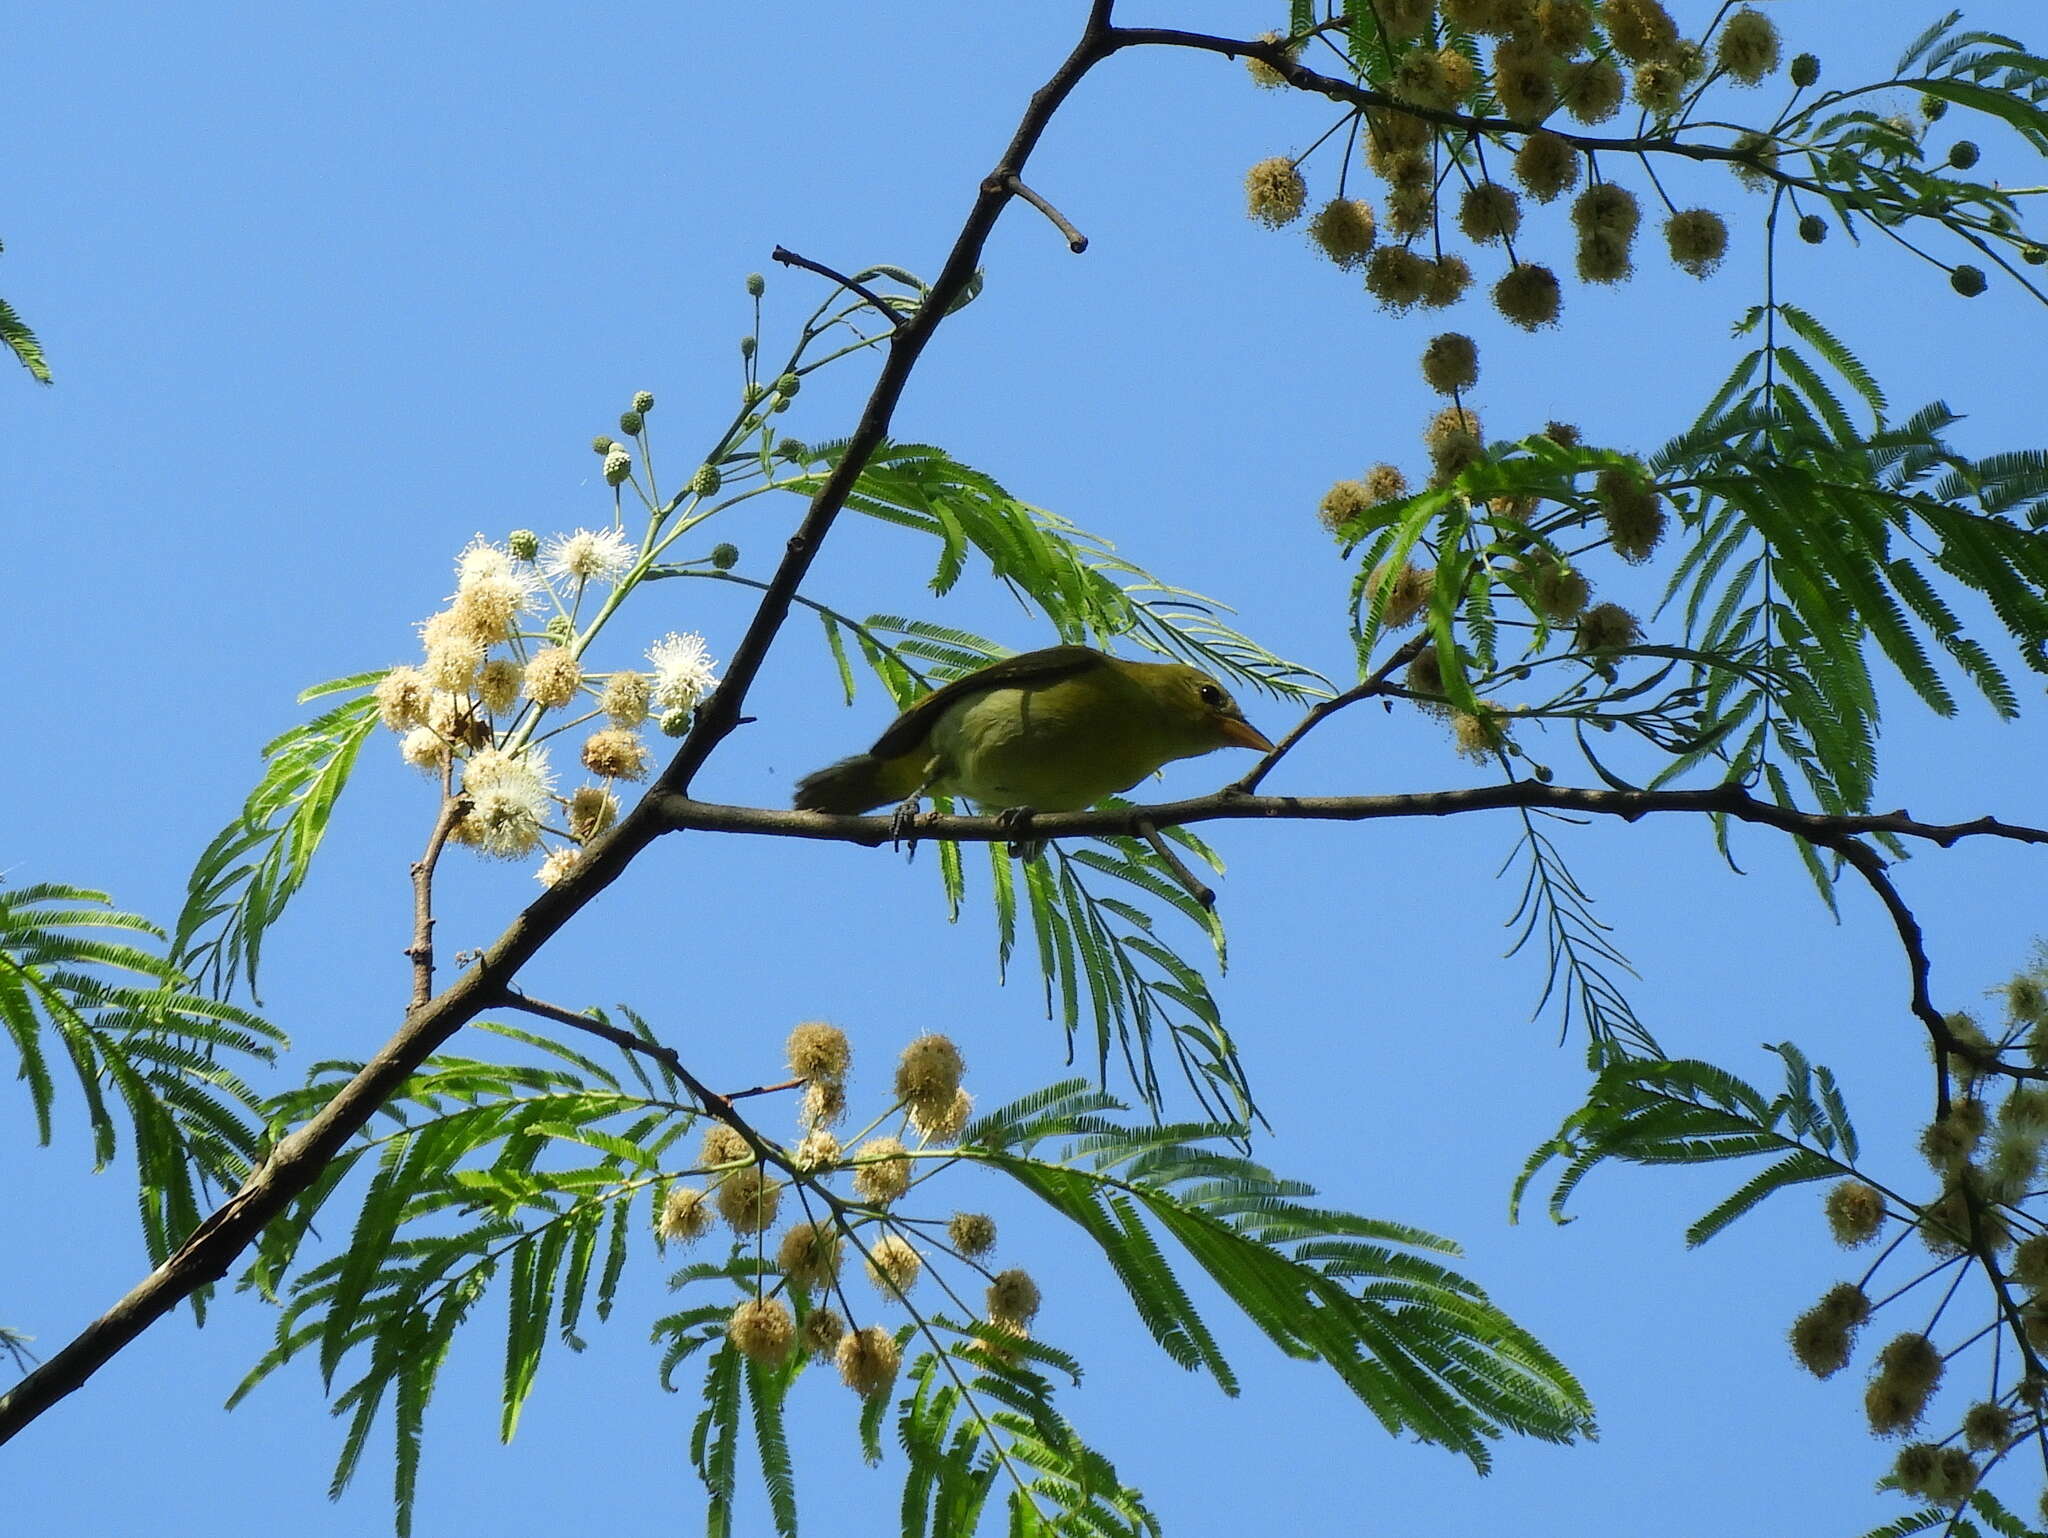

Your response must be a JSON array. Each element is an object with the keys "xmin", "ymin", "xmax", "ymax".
[{"xmin": 12, "ymin": 0, "xmax": 2048, "ymax": 1538}]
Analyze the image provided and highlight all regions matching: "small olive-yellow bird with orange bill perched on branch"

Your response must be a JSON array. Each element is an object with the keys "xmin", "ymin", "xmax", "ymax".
[{"xmin": 795, "ymin": 645, "xmax": 1274, "ymax": 858}]
